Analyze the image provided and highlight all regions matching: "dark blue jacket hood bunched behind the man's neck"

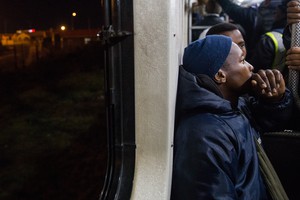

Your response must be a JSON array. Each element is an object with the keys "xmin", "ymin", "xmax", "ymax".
[{"xmin": 176, "ymin": 66, "xmax": 233, "ymax": 119}]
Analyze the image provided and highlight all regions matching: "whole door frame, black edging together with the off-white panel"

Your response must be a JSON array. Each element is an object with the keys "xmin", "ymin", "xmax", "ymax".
[{"xmin": 100, "ymin": 0, "xmax": 189, "ymax": 200}]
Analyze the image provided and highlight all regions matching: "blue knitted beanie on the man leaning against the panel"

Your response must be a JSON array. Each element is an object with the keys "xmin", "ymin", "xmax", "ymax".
[{"xmin": 183, "ymin": 35, "xmax": 232, "ymax": 78}]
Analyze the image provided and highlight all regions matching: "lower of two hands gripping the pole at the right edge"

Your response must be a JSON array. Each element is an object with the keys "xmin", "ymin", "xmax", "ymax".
[{"xmin": 285, "ymin": 47, "xmax": 300, "ymax": 71}]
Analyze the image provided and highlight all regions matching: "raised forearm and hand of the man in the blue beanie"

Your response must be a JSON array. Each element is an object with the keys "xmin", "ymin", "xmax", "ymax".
[{"xmin": 249, "ymin": 69, "xmax": 293, "ymax": 132}]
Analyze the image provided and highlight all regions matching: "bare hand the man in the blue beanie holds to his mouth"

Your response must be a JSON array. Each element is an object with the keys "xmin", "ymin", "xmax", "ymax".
[{"xmin": 251, "ymin": 69, "xmax": 285, "ymax": 101}]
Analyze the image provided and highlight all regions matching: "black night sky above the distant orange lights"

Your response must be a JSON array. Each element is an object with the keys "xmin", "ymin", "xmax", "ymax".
[{"xmin": 0, "ymin": 0, "xmax": 102, "ymax": 33}]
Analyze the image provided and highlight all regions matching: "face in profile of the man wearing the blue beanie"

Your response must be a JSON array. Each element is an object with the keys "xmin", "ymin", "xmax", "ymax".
[{"xmin": 222, "ymin": 43, "xmax": 253, "ymax": 94}]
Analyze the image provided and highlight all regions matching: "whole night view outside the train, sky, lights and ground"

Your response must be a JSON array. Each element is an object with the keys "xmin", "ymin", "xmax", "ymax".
[{"xmin": 0, "ymin": 0, "xmax": 107, "ymax": 200}]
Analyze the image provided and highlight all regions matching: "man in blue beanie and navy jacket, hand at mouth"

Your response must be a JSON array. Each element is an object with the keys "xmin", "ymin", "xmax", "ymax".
[{"xmin": 171, "ymin": 35, "xmax": 292, "ymax": 200}]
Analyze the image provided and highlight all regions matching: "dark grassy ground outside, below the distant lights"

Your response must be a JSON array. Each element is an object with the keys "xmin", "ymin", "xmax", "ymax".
[{"xmin": 0, "ymin": 45, "xmax": 107, "ymax": 200}]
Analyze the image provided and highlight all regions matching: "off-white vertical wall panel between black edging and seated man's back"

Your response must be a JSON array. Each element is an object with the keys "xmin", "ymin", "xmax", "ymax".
[{"xmin": 131, "ymin": 0, "xmax": 187, "ymax": 200}]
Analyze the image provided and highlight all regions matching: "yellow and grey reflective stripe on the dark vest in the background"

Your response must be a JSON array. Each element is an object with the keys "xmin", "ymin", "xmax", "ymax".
[{"xmin": 266, "ymin": 31, "xmax": 285, "ymax": 72}]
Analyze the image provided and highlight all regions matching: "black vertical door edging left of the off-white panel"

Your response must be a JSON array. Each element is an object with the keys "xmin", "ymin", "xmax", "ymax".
[{"xmin": 99, "ymin": 0, "xmax": 135, "ymax": 200}]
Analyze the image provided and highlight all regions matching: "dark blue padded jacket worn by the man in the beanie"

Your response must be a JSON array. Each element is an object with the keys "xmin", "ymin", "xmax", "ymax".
[{"xmin": 171, "ymin": 67, "xmax": 292, "ymax": 200}]
